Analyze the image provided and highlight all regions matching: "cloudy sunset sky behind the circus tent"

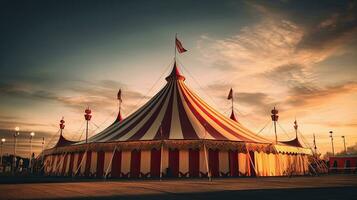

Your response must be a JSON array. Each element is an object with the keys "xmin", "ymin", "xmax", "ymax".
[{"xmin": 0, "ymin": 0, "xmax": 357, "ymax": 155}]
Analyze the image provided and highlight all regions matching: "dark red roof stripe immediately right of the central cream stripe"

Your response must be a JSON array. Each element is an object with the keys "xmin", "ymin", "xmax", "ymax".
[{"xmin": 176, "ymin": 85, "xmax": 199, "ymax": 139}]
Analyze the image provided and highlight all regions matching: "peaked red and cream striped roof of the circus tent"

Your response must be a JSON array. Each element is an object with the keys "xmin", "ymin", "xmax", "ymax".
[{"xmin": 80, "ymin": 64, "xmax": 271, "ymax": 144}]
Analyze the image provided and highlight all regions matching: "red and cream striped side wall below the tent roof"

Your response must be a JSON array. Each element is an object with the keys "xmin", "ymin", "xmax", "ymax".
[{"xmin": 44, "ymin": 148, "xmax": 309, "ymax": 178}]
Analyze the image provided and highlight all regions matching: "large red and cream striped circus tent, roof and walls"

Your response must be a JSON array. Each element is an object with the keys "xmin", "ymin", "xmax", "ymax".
[{"xmin": 44, "ymin": 63, "xmax": 310, "ymax": 178}]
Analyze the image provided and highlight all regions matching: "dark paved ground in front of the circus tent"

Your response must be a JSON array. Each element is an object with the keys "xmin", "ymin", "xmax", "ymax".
[{"xmin": 0, "ymin": 175, "xmax": 357, "ymax": 200}]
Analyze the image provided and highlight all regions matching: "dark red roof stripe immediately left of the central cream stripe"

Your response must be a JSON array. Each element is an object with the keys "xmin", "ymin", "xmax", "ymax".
[{"xmin": 154, "ymin": 83, "xmax": 174, "ymax": 140}]
